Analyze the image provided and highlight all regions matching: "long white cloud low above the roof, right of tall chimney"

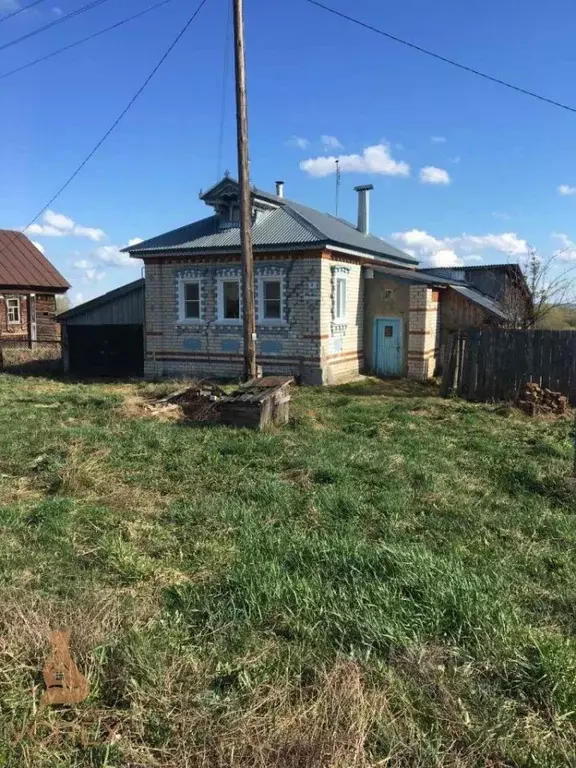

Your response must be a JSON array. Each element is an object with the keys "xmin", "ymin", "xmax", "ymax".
[{"xmin": 392, "ymin": 229, "xmax": 528, "ymax": 267}]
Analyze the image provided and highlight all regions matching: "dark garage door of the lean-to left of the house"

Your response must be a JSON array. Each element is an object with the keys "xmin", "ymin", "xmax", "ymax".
[{"xmin": 67, "ymin": 325, "xmax": 144, "ymax": 376}]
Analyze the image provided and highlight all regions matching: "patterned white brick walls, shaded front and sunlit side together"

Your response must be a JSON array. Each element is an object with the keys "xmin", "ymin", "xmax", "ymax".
[{"xmin": 145, "ymin": 251, "xmax": 364, "ymax": 384}]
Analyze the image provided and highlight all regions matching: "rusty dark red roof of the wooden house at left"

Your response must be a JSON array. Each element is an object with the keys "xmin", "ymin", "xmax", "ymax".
[{"xmin": 0, "ymin": 229, "xmax": 70, "ymax": 293}]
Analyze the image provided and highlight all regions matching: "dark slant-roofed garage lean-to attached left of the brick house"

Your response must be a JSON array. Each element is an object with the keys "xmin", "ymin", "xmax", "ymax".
[{"xmin": 58, "ymin": 279, "xmax": 145, "ymax": 376}]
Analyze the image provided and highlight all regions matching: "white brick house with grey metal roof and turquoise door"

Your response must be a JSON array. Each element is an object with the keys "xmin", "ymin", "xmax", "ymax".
[{"xmin": 125, "ymin": 177, "xmax": 524, "ymax": 384}]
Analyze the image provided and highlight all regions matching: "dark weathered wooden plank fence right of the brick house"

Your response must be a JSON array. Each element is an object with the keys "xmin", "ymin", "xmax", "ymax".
[{"xmin": 441, "ymin": 329, "xmax": 576, "ymax": 405}]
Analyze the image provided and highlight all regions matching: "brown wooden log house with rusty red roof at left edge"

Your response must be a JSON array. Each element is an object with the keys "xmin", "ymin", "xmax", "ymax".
[{"xmin": 0, "ymin": 229, "xmax": 70, "ymax": 347}]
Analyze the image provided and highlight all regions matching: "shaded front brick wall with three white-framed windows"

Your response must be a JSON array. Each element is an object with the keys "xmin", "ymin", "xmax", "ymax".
[{"xmin": 145, "ymin": 252, "xmax": 323, "ymax": 384}]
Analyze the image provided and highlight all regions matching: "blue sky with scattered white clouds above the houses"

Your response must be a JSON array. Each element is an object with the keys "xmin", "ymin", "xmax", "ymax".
[{"xmin": 0, "ymin": 0, "xmax": 576, "ymax": 301}]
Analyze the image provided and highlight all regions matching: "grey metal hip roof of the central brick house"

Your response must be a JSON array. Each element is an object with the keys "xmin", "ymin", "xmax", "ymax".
[{"xmin": 124, "ymin": 178, "xmax": 418, "ymax": 265}]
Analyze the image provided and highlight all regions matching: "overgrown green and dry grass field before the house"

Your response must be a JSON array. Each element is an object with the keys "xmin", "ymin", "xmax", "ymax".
[{"xmin": 0, "ymin": 375, "xmax": 576, "ymax": 768}]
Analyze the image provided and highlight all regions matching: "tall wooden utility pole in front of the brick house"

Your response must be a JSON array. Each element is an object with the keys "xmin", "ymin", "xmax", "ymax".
[{"xmin": 232, "ymin": 0, "xmax": 256, "ymax": 379}]
